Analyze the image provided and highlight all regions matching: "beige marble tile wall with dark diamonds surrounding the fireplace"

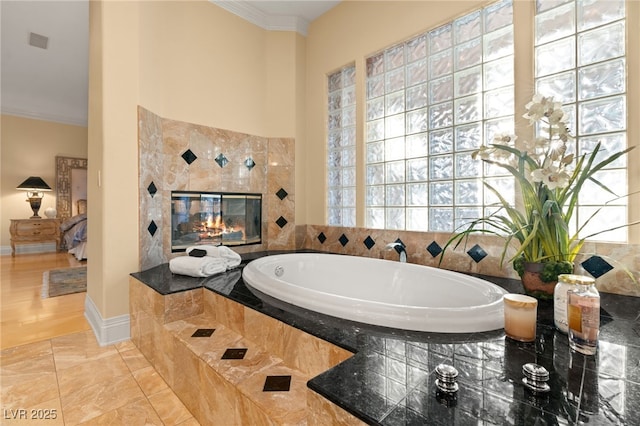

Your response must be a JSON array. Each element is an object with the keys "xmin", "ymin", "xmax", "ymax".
[{"xmin": 138, "ymin": 107, "xmax": 295, "ymax": 269}]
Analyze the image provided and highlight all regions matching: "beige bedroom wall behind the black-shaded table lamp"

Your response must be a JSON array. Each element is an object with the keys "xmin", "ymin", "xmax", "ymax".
[{"xmin": 0, "ymin": 115, "xmax": 87, "ymax": 247}]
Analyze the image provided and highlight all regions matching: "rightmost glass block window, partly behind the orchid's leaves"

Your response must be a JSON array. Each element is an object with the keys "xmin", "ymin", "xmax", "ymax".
[{"xmin": 535, "ymin": 0, "xmax": 627, "ymax": 242}]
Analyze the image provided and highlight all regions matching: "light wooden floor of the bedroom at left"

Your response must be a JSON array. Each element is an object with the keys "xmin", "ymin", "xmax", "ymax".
[{"xmin": 0, "ymin": 252, "xmax": 90, "ymax": 349}]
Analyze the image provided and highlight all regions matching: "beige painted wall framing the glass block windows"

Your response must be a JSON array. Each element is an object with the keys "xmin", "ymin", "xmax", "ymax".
[{"xmin": 297, "ymin": 0, "xmax": 640, "ymax": 243}]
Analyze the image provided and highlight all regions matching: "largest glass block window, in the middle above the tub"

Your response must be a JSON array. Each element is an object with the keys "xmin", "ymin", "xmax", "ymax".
[{"xmin": 365, "ymin": 1, "xmax": 514, "ymax": 232}]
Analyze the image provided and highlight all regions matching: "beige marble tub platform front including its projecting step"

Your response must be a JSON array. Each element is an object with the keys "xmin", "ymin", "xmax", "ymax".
[{"xmin": 129, "ymin": 277, "xmax": 356, "ymax": 425}]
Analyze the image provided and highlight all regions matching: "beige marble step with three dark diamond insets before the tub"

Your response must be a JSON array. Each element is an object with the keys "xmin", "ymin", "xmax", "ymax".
[{"xmin": 163, "ymin": 314, "xmax": 310, "ymax": 425}]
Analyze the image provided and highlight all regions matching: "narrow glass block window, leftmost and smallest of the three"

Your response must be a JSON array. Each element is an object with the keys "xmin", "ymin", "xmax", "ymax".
[{"xmin": 327, "ymin": 66, "xmax": 356, "ymax": 226}]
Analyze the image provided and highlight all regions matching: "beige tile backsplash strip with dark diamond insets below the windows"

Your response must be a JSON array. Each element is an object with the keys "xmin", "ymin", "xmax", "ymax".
[{"xmin": 296, "ymin": 225, "xmax": 640, "ymax": 297}]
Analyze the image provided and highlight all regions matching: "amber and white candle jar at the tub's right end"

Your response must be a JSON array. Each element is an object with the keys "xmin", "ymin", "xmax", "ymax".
[{"xmin": 503, "ymin": 294, "xmax": 538, "ymax": 342}]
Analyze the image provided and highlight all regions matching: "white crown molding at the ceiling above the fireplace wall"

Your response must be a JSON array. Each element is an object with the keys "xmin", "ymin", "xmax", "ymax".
[{"xmin": 209, "ymin": 0, "xmax": 309, "ymax": 36}]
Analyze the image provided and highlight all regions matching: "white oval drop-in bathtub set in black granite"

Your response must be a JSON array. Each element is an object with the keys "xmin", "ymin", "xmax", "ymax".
[{"xmin": 242, "ymin": 253, "xmax": 507, "ymax": 333}]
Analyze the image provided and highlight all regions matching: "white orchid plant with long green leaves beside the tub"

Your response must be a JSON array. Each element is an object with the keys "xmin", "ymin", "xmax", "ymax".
[{"xmin": 441, "ymin": 95, "xmax": 632, "ymax": 281}]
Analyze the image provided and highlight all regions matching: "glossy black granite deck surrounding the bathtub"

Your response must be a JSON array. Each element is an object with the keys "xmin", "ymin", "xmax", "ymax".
[{"xmin": 131, "ymin": 252, "xmax": 640, "ymax": 426}]
